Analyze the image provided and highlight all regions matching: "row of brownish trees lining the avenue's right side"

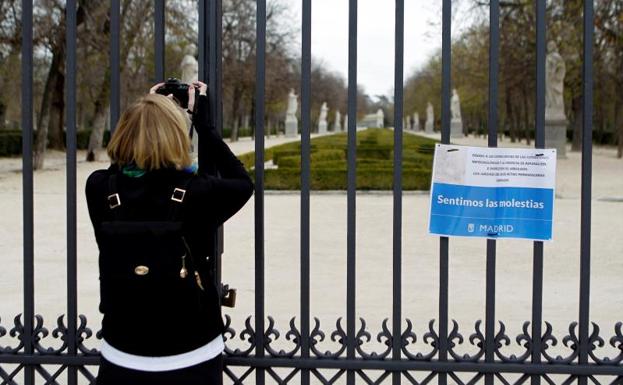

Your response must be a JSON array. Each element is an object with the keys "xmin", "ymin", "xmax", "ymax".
[{"xmin": 405, "ymin": 0, "xmax": 623, "ymax": 153}]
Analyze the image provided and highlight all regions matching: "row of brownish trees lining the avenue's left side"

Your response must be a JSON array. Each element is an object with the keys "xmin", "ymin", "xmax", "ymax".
[{"xmin": 0, "ymin": 0, "xmax": 380, "ymax": 163}]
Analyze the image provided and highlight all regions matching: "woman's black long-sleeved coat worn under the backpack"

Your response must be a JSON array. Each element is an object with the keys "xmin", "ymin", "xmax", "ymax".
[{"xmin": 86, "ymin": 96, "xmax": 253, "ymax": 356}]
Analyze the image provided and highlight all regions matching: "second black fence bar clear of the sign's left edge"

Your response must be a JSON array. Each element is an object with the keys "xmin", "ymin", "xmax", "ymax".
[{"xmin": 346, "ymin": 0, "xmax": 357, "ymax": 385}]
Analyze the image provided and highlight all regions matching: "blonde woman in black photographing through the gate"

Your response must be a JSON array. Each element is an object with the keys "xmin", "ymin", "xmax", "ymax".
[{"xmin": 86, "ymin": 82, "xmax": 253, "ymax": 385}]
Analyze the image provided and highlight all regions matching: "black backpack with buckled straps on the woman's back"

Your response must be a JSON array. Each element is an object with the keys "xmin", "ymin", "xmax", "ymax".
[{"xmin": 99, "ymin": 174, "xmax": 205, "ymax": 327}]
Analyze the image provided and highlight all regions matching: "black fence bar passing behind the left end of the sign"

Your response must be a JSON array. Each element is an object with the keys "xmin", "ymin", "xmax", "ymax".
[{"xmin": 439, "ymin": 0, "xmax": 452, "ymax": 385}]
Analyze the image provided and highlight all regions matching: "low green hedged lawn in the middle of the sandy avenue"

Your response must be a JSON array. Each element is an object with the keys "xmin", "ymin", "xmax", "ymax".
[{"xmin": 239, "ymin": 129, "xmax": 435, "ymax": 190}]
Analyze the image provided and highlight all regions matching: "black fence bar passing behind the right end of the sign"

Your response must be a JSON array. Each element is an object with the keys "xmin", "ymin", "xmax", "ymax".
[{"xmin": 530, "ymin": 0, "xmax": 547, "ymax": 385}]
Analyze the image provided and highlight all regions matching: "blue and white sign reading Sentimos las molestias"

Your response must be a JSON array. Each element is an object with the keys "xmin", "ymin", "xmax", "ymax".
[{"xmin": 429, "ymin": 144, "xmax": 556, "ymax": 240}]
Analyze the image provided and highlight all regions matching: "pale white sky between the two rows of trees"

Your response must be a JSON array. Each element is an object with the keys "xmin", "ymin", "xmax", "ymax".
[{"xmin": 283, "ymin": 0, "xmax": 472, "ymax": 97}]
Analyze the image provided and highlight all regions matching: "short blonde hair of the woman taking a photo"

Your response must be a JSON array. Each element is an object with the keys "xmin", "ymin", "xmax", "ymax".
[{"xmin": 107, "ymin": 94, "xmax": 192, "ymax": 170}]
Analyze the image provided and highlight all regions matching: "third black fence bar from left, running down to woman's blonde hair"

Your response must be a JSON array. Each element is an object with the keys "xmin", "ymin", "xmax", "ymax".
[{"xmin": 110, "ymin": 0, "xmax": 121, "ymax": 136}]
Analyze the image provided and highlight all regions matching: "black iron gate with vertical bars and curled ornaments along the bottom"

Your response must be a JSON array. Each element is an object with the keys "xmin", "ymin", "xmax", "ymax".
[{"xmin": 0, "ymin": 0, "xmax": 623, "ymax": 385}]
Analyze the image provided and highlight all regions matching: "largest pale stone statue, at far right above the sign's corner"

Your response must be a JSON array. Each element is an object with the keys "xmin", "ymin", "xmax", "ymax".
[{"xmin": 545, "ymin": 41, "xmax": 566, "ymax": 120}]
